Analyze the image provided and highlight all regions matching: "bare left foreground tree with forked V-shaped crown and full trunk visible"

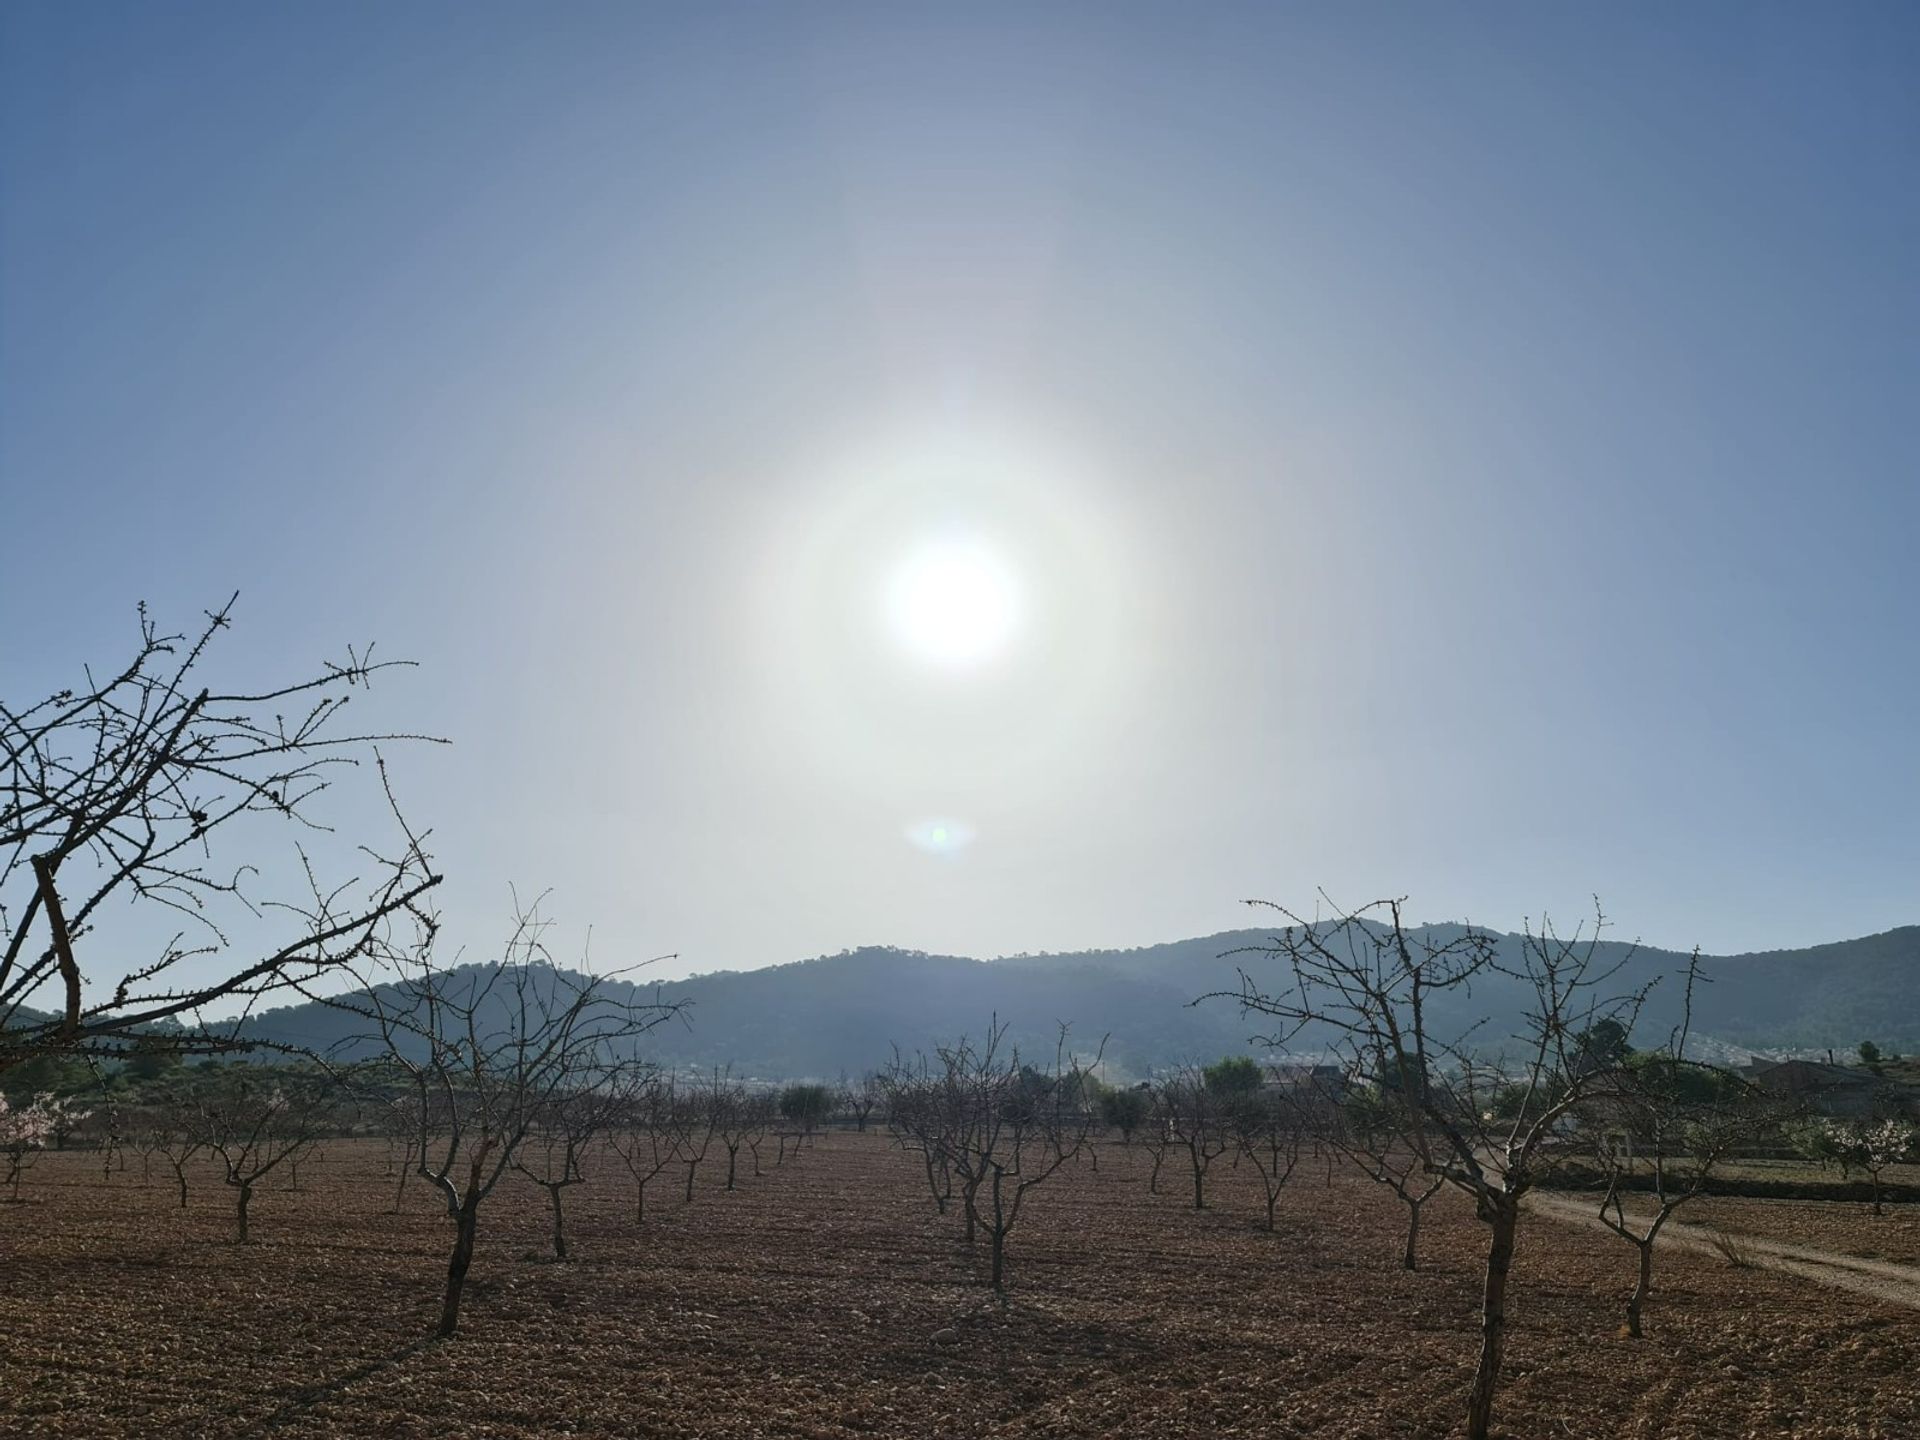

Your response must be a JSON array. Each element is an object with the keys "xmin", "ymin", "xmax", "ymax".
[{"xmin": 328, "ymin": 904, "xmax": 678, "ymax": 1336}]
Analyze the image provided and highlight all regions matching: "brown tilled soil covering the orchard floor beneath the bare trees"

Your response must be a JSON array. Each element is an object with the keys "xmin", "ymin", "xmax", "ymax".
[{"xmin": 0, "ymin": 1135, "xmax": 1920, "ymax": 1440}]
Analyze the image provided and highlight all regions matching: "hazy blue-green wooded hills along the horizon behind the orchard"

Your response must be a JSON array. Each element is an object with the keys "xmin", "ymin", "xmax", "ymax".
[{"xmin": 236, "ymin": 925, "xmax": 1920, "ymax": 1079}]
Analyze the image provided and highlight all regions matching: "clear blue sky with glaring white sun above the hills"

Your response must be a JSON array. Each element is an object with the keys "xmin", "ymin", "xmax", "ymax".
[{"xmin": 0, "ymin": 0, "xmax": 1920, "ymax": 977}]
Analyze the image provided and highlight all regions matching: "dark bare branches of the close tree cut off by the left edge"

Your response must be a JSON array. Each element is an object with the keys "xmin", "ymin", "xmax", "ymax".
[{"xmin": 0, "ymin": 599, "xmax": 440, "ymax": 1069}]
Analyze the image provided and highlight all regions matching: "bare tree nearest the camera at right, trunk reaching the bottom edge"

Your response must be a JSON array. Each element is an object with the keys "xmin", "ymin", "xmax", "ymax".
[{"xmin": 1202, "ymin": 900, "xmax": 1681, "ymax": 1440}]
